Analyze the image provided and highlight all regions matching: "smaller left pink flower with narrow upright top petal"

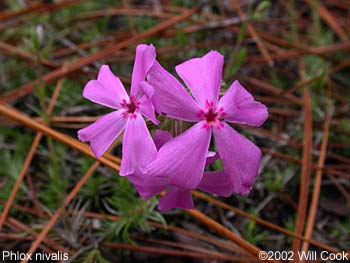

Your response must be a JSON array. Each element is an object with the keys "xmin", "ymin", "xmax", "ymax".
[{"xmin": 78, "ymin": 45, "xmax": 158, "ymax": 175}]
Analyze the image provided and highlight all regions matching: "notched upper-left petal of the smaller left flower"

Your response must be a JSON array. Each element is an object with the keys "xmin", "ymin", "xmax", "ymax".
[{"xmin": 83, "ymin": 65, "xmax": 129, "ymax": 109}]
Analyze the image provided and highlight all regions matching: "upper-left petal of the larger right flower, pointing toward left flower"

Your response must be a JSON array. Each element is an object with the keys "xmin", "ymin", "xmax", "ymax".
[{"xmin": 147, "ymin": 61, "xmax": 200, "ymax": 122}]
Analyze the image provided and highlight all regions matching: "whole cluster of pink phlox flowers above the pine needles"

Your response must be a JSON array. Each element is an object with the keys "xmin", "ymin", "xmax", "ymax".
[{"xmin": 78, "ymin": 44, "xmax": 268, "ymax": 210}]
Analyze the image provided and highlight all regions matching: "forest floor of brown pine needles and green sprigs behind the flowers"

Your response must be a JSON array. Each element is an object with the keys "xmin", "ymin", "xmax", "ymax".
[{"xmin": 0, "ymin": 0, "xmax": 350, "ymax": 263}]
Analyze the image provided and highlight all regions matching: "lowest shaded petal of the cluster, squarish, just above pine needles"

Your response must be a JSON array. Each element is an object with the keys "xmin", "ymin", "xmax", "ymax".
[{"xmin": 158, "ymin": 187, "xmax": 194, "ymax": 211}]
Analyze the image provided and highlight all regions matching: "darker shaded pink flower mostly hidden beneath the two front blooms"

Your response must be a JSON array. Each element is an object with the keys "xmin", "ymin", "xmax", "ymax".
[{"xmin": 127, "ymin": 130, "xmax": 233, "ymax": 210}]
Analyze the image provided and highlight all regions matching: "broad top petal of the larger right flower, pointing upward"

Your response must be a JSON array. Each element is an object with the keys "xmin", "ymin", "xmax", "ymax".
[{"xmin": 176, "ymin": 51, "xmax": 224, "ymax": 106}]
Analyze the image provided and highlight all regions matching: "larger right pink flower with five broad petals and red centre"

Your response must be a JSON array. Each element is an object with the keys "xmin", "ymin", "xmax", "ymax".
[{"xmin": 143, "ymin": 51, "xmax": 268, "ymax": 198}]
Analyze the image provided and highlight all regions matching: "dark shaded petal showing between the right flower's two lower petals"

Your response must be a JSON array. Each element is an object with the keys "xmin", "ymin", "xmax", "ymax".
[{"xmin": 198, "ymin": 171, "xmax": 233, "ymax": 197}]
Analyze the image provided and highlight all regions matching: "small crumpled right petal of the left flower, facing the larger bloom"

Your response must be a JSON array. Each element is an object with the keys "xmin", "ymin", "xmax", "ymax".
[{"xmin": 139, "ymin": 81, "xmax": 159, "ymax": 125}]
